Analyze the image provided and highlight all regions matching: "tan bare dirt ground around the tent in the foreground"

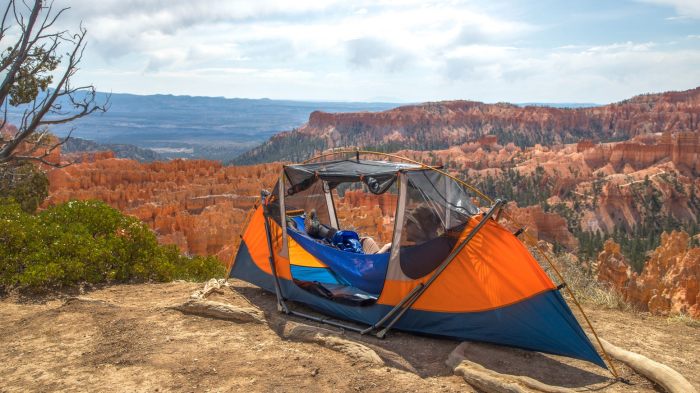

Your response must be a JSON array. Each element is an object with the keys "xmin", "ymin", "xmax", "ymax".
[{"xmin": 0, "ymin": 280, "xmax": 700, "ymax": 393}]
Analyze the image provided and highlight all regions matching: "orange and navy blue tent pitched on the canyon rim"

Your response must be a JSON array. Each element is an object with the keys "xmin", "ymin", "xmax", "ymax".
[{"xmin": 229, "ymin": 151, "xmax": 607, "ymax": 368}]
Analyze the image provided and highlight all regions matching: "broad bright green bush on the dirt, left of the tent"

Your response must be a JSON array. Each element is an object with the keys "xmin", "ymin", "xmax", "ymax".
[{"xmin": 0, "ymin": 199, "xmax": 224, "ymax": 288}]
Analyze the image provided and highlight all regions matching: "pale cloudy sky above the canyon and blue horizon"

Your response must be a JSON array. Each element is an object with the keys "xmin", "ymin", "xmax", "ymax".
[{"xmin": 20, "ymin": 0, "xmax": 700, "ymax": 104}]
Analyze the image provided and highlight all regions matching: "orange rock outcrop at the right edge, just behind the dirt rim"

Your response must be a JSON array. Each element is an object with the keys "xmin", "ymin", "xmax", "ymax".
[{"xmin": 597, "ymin": 231, "xmax": 700, "ymax": 318}]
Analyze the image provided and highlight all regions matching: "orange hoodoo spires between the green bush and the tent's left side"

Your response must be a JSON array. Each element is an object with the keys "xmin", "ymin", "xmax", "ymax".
[{"xmin": 46, "ymin": 153, "xmax": 279, "ymax": 263}]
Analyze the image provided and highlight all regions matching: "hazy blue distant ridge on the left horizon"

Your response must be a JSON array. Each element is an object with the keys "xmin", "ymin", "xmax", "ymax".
[{"xmin": 8, "ymin": 93, "xmax": 398, "ymax": 161}]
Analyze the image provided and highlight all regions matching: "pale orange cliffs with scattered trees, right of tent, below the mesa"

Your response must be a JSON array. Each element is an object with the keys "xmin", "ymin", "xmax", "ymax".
[{"xmin": 399, "ymin": 132, "xmax": 700, "ymax": 240}]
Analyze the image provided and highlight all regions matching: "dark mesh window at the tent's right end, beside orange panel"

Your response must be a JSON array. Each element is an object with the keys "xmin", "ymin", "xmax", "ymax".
[{"xmin": 399, "ymin": 170, "xmax": 479, "ymax": 279}]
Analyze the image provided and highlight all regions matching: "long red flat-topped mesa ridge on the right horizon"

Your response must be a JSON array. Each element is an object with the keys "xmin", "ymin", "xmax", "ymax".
[{"xmin": 231, "ymin": 87, "xmax": 700, "ymax": 164}]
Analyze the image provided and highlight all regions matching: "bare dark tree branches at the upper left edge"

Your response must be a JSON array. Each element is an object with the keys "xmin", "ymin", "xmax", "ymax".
[{"xmin": 0, "ymin": 0, "xmax": 109, "ymax": 167}]
